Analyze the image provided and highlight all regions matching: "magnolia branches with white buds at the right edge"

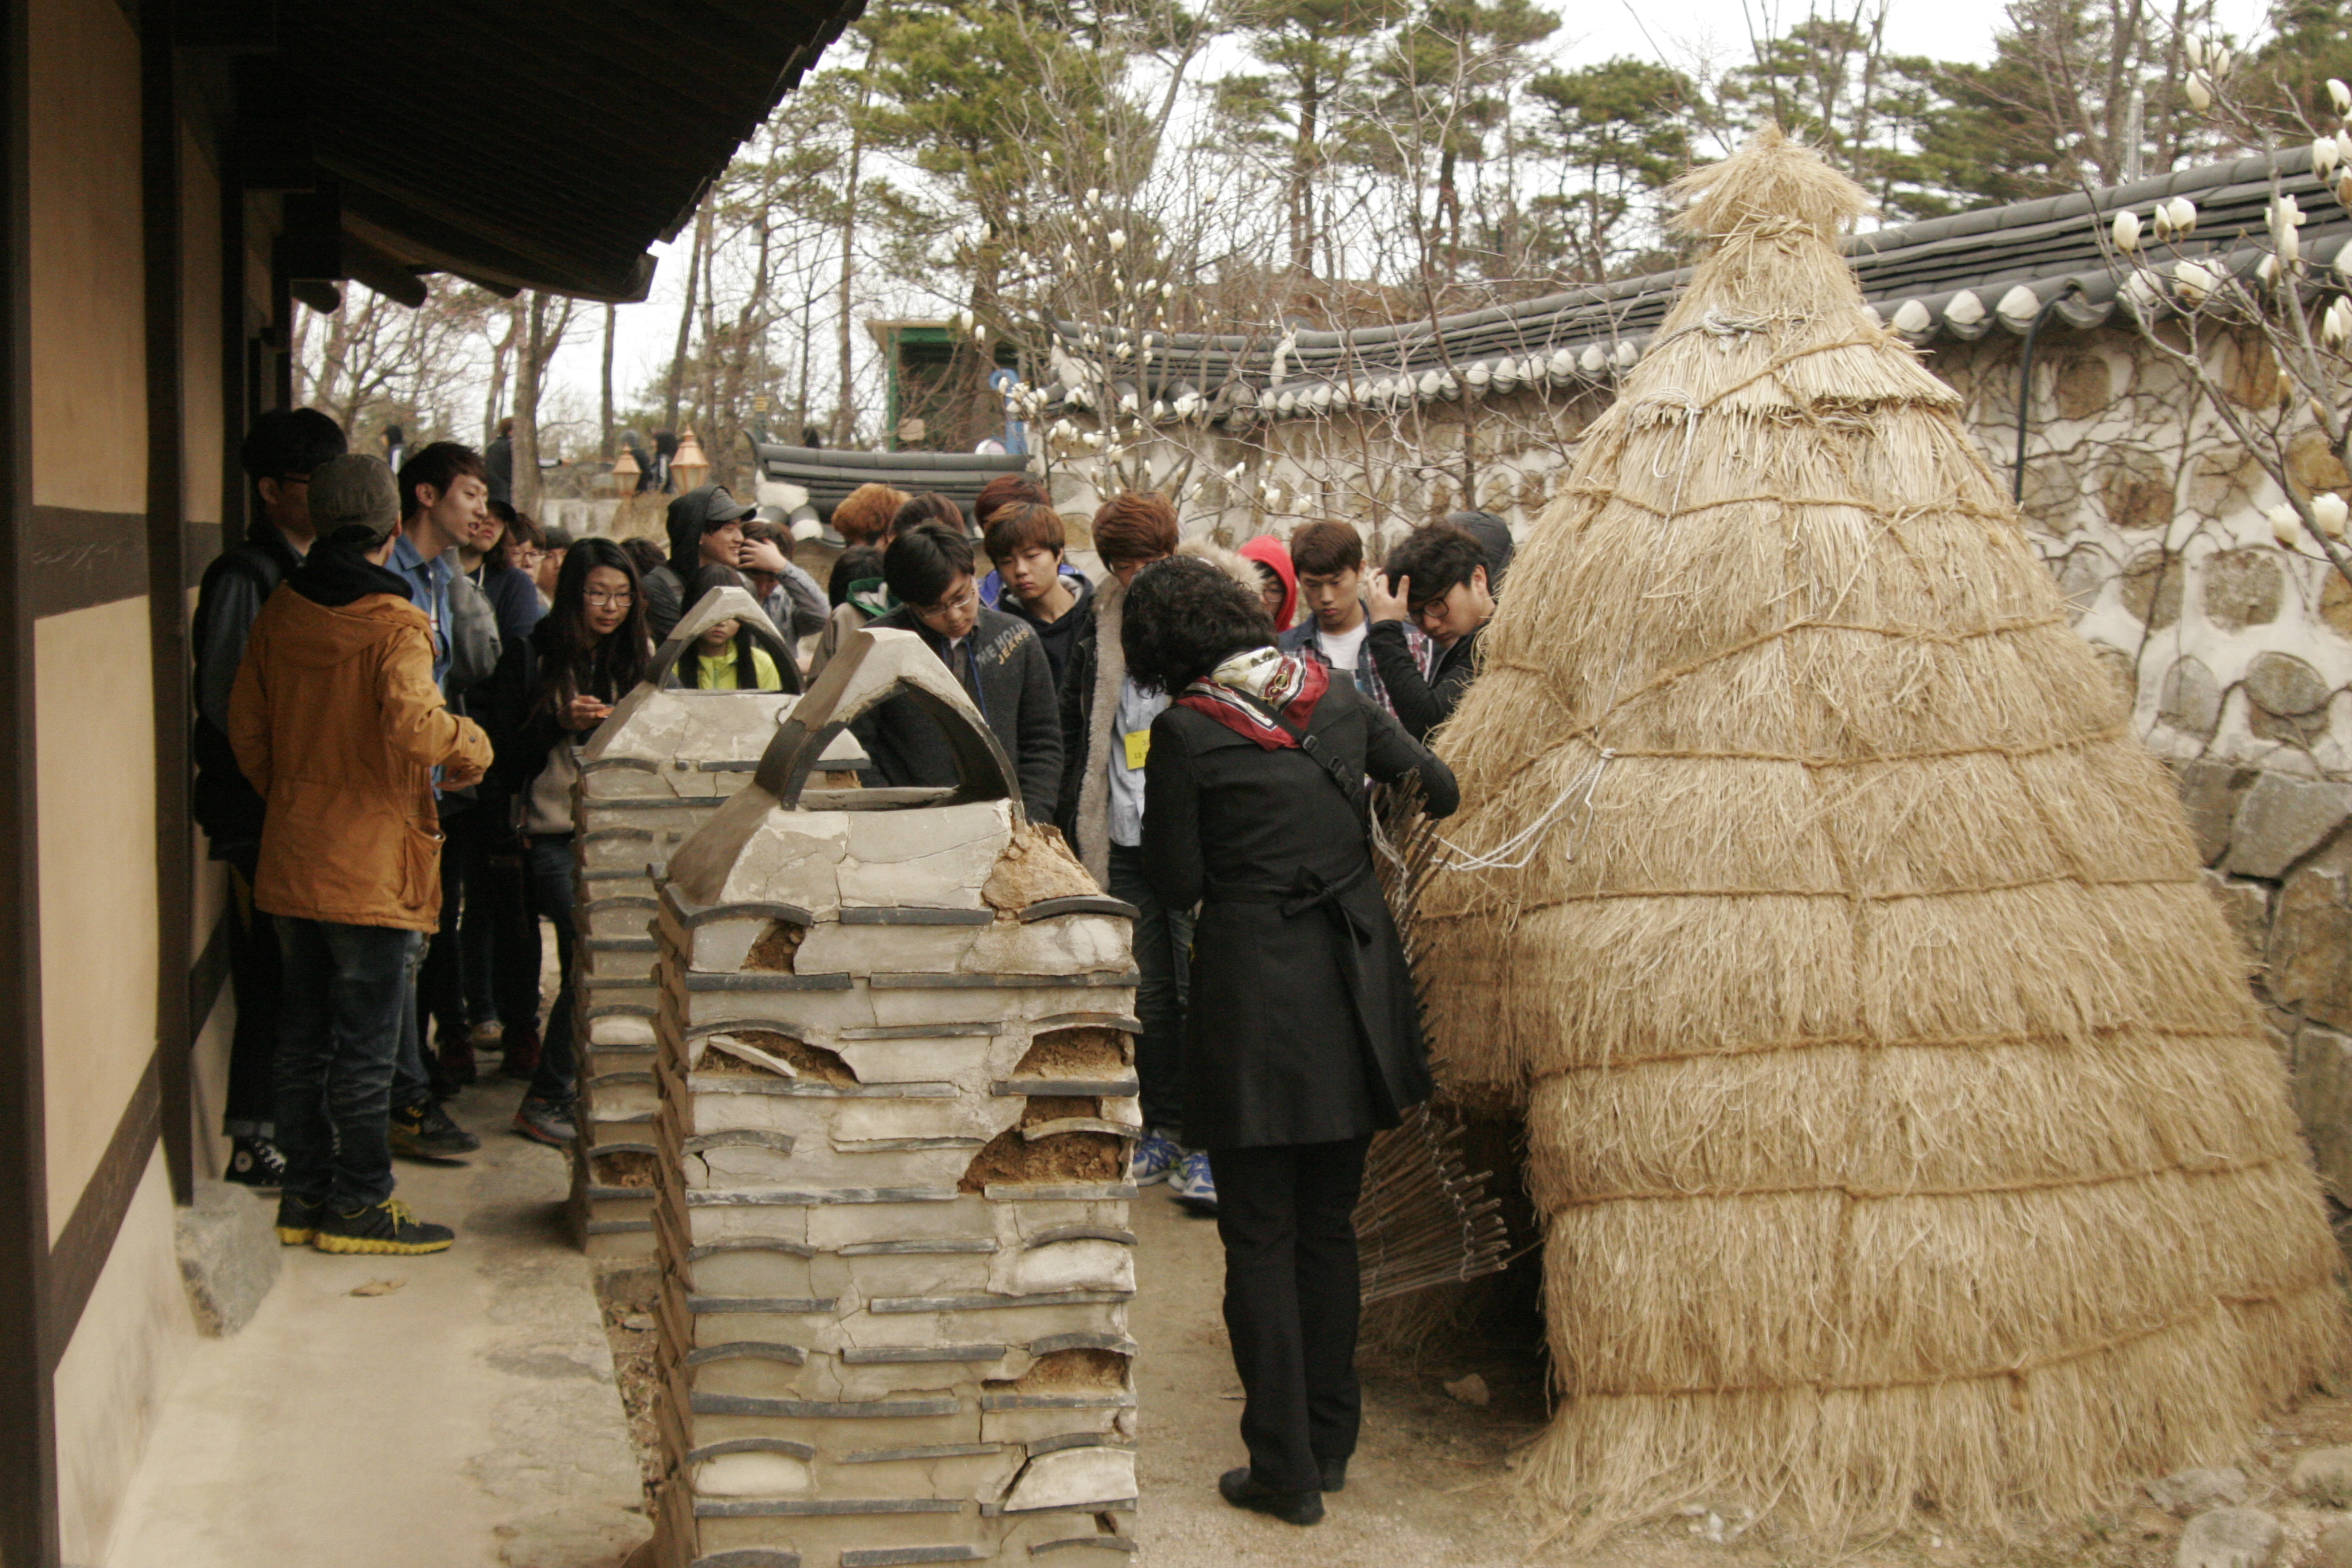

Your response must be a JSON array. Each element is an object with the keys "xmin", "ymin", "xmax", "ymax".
[{"xmin": 2105, "ymin": 38, "xmax": 2352, "ymax": 595}]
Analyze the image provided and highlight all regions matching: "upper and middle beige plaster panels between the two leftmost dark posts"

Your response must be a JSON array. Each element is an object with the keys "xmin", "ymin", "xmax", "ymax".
[{"xmin": 31, "ymin": 0, "xmax": 155, "ymax": 1236}]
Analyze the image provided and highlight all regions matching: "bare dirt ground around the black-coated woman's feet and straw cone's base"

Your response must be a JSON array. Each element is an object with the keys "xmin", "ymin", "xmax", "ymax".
[{"xmin": 605, "ymin": 1189, "xmax": 2352, "ymax": 1568}]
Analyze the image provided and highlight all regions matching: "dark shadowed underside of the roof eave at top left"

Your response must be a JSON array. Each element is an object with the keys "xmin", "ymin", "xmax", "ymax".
[{"xmin": 287, "ymin": 0, "xmax": 863, "ymax": 303}]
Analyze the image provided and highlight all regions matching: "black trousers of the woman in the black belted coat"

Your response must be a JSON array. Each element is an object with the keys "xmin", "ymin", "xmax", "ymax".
[{"xmin": 1209, "ymin": 1138, "xmax": 1371, "ymax": 1493}]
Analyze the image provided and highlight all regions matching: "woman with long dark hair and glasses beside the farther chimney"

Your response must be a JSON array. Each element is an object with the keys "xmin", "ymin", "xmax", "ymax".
[{"xmin": 494, "ymin": 538, "xmax": 654, "ymax": 1147}]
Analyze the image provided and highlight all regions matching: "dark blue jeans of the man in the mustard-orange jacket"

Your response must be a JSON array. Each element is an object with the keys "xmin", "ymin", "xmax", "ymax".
[{"xmin": 273, "ymin": 914, "xmax": 424, "ymax": 1213}]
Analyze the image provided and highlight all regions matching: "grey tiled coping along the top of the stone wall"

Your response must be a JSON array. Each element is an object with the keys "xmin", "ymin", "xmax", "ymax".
[{"xmin": 1056, "ymin": 150, "xmax": 2352, "ymax": 423}]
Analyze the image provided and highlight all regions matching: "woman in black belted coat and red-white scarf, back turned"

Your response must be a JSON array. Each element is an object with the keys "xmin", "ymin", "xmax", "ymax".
[{"xmin": 1120, "ymin": 557, "xmax": 1458, "ymax": 1523}]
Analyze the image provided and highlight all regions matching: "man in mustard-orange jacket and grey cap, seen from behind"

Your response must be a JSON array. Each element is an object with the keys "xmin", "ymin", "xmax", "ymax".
[{"xmin": 228, "ymin": 456, "xmax": 489, "ymax": 1253}]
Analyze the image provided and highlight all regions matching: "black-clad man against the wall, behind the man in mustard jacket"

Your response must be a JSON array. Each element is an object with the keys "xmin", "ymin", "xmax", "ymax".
[{"xmin": 191, "ymin": 409, "xmax": 346, "ymax": 1187}]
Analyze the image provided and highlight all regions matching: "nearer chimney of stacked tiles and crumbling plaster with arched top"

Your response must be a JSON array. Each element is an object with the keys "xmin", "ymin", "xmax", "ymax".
[{"xmin": 654, "ymin": 632, "xmax": 1140, "ymax": 1568}]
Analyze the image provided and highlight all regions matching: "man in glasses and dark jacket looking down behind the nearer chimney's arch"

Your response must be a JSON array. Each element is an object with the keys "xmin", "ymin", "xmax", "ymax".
[{"xmin": 849, "ymin": 522, "xmax": 1061, "ymax": 823}]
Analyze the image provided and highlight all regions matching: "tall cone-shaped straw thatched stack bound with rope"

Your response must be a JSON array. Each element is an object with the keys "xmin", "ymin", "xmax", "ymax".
[{"xmin": 1420, "ymin": 134, "xmax": 2345, "ymax": 1530}]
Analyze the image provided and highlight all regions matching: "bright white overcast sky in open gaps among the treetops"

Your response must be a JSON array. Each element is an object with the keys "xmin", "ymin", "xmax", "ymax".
[{"xmin": 552, "ymin": 0, "xmax": 2269, "ymax": 434}]
